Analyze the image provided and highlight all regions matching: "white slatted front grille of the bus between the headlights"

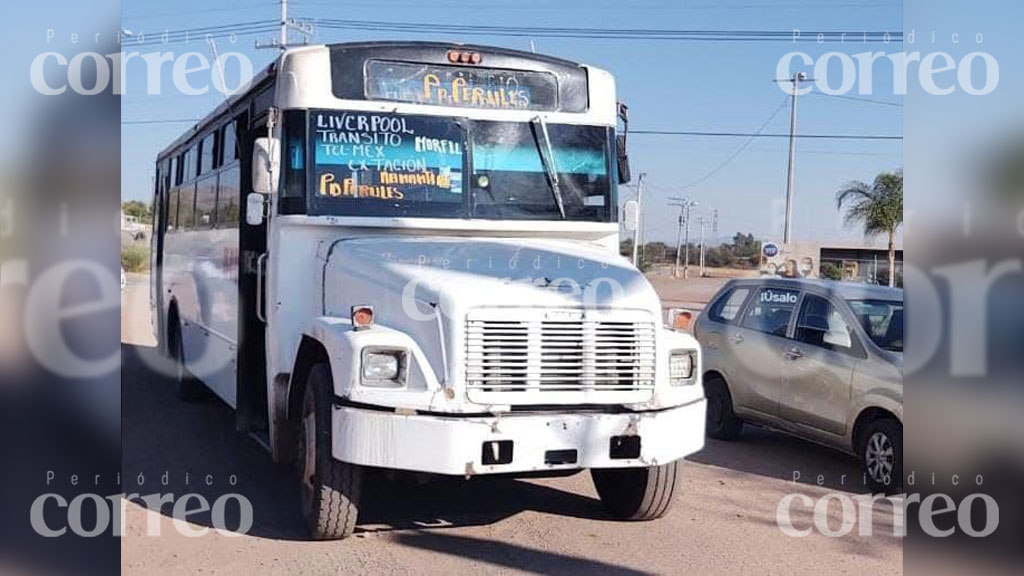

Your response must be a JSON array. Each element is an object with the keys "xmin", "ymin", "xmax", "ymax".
[{"xmin": 466, "ymin": 313, "xmax": 655, "ymax": 393}]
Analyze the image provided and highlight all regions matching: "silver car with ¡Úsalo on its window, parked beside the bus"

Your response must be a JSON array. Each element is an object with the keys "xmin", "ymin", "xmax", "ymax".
[{"xmin": 693, "ymin": 278, "xmax": 903, "ymax": 493}]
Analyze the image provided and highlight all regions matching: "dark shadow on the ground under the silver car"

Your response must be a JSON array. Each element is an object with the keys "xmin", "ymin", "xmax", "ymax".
[{"xmin": 687, "ymin": 425, "xmax": 870, "ymax": 494}]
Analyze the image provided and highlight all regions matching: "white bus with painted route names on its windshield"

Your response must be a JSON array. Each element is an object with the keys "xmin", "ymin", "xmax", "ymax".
[{"xmin": 152, "ymin": 42, "xmax": 705, "ymax": 539}]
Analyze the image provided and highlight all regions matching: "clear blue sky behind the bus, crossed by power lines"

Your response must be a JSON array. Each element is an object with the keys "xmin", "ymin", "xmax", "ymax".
[{"xmin": 121, "ymin": 0, "xmax": 903, "ymax": 241}]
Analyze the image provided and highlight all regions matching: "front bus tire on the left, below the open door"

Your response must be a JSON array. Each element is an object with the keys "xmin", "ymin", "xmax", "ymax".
[{"xmin": 295, "ymin": 364, "xmax": 362, "ymax": 540}]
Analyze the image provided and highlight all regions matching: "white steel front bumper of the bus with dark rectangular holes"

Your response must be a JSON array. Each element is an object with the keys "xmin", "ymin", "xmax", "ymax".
[{"xmin": 332, "ymin": 399, "xmax": 706, "ymax": 476}]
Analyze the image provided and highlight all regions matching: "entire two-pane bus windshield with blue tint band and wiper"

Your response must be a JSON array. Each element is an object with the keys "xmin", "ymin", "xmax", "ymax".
[{"xmin": 308, "ymin": 111, "xmax": 617, "ymax": 222}]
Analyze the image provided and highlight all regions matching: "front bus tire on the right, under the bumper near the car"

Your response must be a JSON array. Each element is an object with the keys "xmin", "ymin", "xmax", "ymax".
[{"xmin": 590, "ymin": 460, "xmax": 682, "ymax": 522}]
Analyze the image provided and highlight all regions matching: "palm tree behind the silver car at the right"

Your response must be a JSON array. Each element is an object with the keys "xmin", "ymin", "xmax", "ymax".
[{"xmin": 836, "ymin": 170, "xmax": 903, "ymax": 286}]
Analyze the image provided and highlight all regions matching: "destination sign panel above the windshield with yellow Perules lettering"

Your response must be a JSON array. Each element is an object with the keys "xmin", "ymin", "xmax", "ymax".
[{"xmin": 367, "ymin": 60, "xmax": 558, "ymax": 111}]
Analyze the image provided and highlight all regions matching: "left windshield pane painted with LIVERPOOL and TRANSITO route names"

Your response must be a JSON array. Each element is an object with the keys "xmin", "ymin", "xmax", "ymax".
[{"xmin": 311, "ymin": 113, "xmax": 465, "ymax": 202}]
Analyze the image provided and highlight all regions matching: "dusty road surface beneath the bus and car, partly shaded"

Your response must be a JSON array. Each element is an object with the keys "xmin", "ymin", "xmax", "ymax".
[{"xmin": 121, "ymin": 278, "xmax": 903, "ymax": 575}]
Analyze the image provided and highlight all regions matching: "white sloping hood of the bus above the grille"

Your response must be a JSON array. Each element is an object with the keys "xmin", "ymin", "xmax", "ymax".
[{"xmin": 322, "ymin": 237, "xmax": 660, "ymax": 323}]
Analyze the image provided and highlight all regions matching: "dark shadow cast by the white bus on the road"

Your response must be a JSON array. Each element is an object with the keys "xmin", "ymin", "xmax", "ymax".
[{"xmin": 121, "ymin": 343, "xmax": 610, "ymax": 542}]
